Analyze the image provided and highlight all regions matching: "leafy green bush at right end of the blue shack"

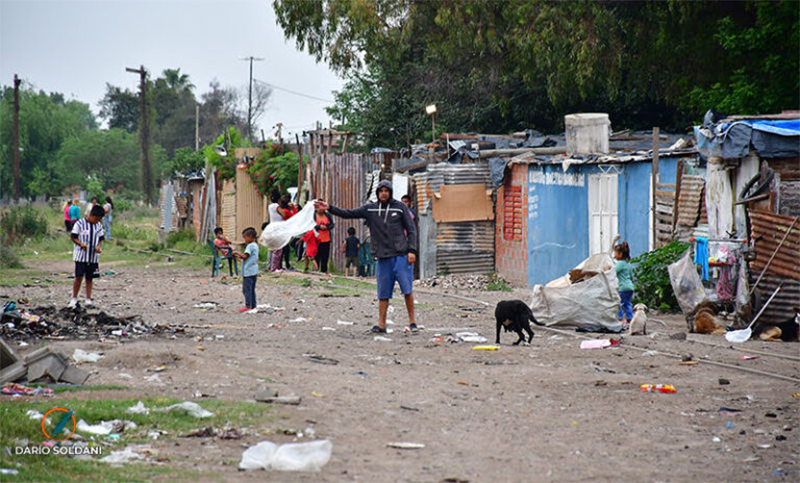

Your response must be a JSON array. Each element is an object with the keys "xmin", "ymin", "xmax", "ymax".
[{"xmin": 631, "ymin": 241, "xmax": 689, "ymax": 312}]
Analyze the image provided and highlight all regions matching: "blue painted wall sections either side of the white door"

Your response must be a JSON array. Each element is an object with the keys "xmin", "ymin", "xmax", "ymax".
[{"xmin": 527, "ymin": 158, "xmax": 678, "ymax": 286}]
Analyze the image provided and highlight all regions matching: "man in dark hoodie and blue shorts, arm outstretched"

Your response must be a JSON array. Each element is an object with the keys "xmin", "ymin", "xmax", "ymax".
[{"xmin": 315, "ymin": 180, "xmax": 418, "ymax": 333}]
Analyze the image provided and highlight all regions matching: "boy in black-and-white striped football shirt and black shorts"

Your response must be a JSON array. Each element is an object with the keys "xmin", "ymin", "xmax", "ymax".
[{"xmin": 69, "ymin": 205, "xmax": 105, "ymax": 308}]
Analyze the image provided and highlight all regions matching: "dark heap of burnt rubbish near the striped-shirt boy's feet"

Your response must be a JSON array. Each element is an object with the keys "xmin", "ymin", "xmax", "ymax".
[{"xmin": 0, "ymin": 302, "xmax": 156, "ymax": 342}]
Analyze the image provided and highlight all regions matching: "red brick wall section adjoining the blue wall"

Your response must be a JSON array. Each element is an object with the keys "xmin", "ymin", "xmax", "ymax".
[{"xmin": 495, "ymin": 164, "xmax": 528, "ymax": 286}]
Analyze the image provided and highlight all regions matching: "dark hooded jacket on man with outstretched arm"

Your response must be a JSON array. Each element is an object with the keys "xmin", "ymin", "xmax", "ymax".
[{"xmin": 328, "ymin": 180, "xmax": 417, "ymax": 258}]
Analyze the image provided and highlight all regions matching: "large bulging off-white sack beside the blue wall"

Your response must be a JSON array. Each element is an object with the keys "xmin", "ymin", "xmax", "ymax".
[{"xmin": 531, "ymin": 253, "xmax": 622, "ymax": 332}]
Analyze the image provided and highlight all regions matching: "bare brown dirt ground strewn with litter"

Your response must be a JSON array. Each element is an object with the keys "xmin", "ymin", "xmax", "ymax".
[{"xmin": 0, "ymin": 262, "xmax": 800, "ymax": 482}]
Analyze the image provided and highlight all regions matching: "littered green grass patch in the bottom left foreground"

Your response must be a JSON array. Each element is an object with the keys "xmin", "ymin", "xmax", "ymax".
[{"xmin": 0, "ymin": 398, "xmax": 278, "ymax": 482}]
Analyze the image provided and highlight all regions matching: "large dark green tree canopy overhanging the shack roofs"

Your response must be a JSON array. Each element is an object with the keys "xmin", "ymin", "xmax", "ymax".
[{"xmin": 273, "ymin": 0, "xmax": 800, "ymax": 145}]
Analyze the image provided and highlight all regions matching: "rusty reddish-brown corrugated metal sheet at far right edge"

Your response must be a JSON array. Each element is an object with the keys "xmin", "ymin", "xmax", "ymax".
[{"xmin": 750, "ymin": 211, "xmax": 800, "ymax": 323}]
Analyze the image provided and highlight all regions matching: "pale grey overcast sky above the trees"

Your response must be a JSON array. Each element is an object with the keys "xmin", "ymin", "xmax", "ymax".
[{"xmin": 0, "ymin": 0, "xmax": 342, "ymax": 141}]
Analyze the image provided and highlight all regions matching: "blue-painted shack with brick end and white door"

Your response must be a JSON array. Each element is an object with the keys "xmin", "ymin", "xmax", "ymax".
[{"xmin": 494, "ymin": 124, "xmax": 696, "ymax": 286}]
